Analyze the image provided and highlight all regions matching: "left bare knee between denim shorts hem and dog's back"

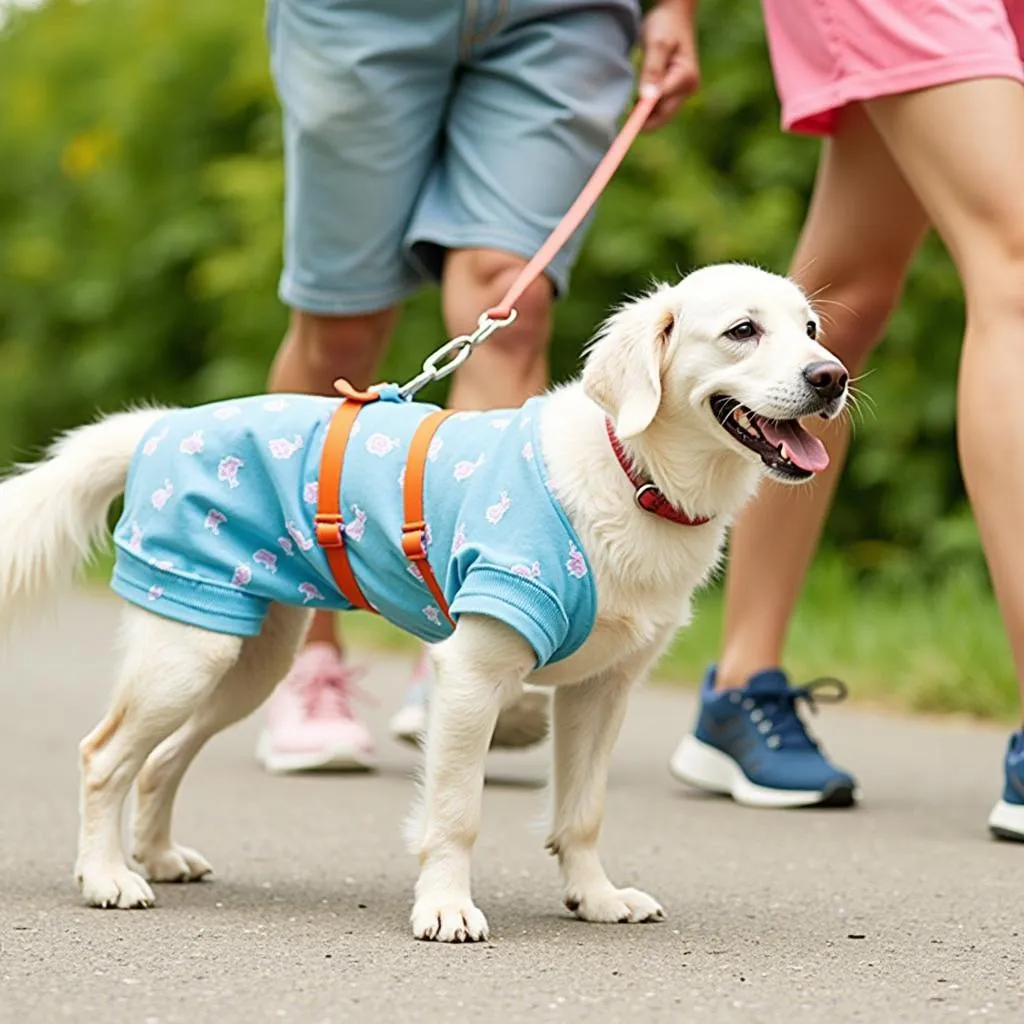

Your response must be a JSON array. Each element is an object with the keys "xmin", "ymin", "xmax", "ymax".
[{"xmin": 289, "ymin": 309, "xmax": 397, "ymax": 392}]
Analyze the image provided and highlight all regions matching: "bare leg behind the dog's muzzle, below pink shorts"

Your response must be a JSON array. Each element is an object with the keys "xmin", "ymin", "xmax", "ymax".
[{"xmin": 717, "ymin": 106, "xmax": 927, "ymax": 687}]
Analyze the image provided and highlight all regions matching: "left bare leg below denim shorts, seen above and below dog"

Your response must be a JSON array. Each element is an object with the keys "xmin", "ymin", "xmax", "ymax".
[{"xmin": 270, "ymin": 309, "xmax": 398, "ymax": 651}]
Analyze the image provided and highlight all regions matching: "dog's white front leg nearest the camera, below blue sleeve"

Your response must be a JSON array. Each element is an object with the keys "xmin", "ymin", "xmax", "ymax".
[{"xmin": 412, "ymin": 615, "xmax": 535, "ymax": 942}]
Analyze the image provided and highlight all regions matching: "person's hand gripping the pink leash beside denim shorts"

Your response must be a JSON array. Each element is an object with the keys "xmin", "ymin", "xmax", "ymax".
[{"xmin": 640, "ymin": 0, "xmax": 700, "ymax": 130}]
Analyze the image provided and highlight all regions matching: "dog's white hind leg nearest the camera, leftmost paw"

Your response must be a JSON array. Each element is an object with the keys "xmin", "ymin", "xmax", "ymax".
[{"xmin": 75, "ymin": 606, "xmax": 242, "ymax": 909}]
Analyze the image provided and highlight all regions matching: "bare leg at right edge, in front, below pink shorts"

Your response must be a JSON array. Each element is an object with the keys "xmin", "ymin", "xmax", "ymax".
[{"xmin": 868, "ymin": 79, "xmax": 1024, "ymax": 712}]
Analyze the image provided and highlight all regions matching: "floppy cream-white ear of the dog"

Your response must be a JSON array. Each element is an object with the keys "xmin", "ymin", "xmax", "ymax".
[{"xmin": 583, "ymin": 288, "xmax": 675, "ymax": 440}]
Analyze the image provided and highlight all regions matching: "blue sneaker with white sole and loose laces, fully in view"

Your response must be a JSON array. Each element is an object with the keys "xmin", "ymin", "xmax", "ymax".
[{"xmin": 669, "ymin": 667, "xmax": 860, "ymax": 806}]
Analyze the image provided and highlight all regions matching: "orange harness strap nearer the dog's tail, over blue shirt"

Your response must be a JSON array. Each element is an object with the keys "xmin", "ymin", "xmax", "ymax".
[{"xmin": 313, "ymin": 380, "xmax": 380, "ymax": 611}]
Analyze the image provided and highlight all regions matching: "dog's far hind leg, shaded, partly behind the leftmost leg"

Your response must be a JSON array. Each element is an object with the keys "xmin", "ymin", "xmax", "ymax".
[{"xmin": 132, "ymin": 604, "xmax": 309, "ymax": 882}]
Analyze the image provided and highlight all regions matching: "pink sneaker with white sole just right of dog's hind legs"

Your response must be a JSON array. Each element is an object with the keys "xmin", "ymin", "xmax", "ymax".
[{"xmin": 256, "ymin": 643, "xmax": 374, "ymax": 774}]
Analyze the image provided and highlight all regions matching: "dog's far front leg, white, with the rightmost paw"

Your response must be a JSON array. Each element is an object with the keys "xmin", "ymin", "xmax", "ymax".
[{"xmin": 547, "ymin": 641, "xmax": 667, "ymax": 923}]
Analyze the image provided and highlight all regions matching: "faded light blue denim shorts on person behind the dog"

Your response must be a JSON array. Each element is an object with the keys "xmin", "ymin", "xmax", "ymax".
[{"xmin": 267, "ymin": 0, "xmax": 639, "ymax": 314}]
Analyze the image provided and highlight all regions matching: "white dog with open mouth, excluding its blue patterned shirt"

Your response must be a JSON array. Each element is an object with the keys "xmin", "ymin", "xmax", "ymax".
[{"xmin": 0, "ymin": 264, "xmax": 848, "ymax": 942}]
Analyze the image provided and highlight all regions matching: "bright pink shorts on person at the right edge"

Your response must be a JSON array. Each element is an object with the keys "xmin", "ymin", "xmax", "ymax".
[{"xmin": 763, "ymin": 0, "xmax": 1024, "ymax": 135}]
